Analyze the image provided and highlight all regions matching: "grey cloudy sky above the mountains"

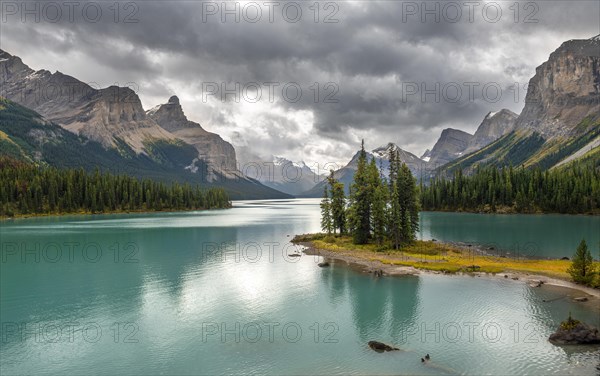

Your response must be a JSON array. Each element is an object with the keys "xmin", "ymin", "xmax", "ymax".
[{"xmin": 0, "ymin": 0, "xmax": 600, "ymax": 163}]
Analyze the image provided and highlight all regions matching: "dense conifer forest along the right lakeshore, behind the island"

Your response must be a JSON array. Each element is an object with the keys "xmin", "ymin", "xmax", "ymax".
[{"xmin": 421, "ymin": 162, "xmax": 600, "ymax": 214}]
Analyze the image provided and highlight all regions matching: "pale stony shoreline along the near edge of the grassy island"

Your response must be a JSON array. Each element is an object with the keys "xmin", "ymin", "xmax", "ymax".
[{"xmin": 295, "ymin": 241, "xmax": 600, "ymax": 305}]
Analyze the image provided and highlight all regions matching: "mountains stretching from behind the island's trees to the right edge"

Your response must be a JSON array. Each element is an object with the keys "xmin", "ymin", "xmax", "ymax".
[{"xmin": 303, "ymin": 35, "xmax": 600, "ymax": 197}]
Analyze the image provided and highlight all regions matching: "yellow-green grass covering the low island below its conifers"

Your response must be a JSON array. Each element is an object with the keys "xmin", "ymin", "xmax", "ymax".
[{"xmin": 292, "ymin": 234, "xmax": 600, "ymax": 284}]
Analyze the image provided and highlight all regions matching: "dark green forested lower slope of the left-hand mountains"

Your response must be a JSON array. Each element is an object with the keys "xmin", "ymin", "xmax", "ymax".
[{"xmin": 0, "ymin": 97, "xmax": 289, "ymax": 199}]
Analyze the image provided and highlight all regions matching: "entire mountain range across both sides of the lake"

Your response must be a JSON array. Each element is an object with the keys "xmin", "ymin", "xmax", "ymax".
[{"xmin": 0, "ymin": 36, "xmax": 600, "ymax": 199}]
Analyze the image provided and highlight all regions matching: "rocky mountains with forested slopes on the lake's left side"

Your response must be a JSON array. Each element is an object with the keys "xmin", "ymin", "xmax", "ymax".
[{"xmin": 0, "ymin": 50, "xmax": 289, "ymax": 199}]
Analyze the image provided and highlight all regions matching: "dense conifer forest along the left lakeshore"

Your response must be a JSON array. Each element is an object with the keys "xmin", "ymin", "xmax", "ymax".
[{"xmin": 0, "ymin": 157, "xmax": 231, "ymax": 217}]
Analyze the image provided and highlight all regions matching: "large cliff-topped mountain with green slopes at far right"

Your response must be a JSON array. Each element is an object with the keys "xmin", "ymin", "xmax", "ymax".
[{"xmin": 441, "ymin": 37, "xmax": 600, "ymax": 173}]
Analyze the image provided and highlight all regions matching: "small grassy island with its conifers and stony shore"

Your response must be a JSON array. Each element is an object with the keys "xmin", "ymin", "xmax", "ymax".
[{"xmin": 292, "ymin": 143, "xmax": 600, "ymax": 289}]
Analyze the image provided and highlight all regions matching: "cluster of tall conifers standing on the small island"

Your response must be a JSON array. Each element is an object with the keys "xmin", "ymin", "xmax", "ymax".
[{"xmin": 320, "ymin": 141, "xmax": 419, "ymax": 249}]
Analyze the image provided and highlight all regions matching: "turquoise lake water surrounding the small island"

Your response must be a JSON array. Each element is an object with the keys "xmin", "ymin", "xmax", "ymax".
[{"xmin": 0, "ymin": 199, "xmax": 600, "ymax": 375}]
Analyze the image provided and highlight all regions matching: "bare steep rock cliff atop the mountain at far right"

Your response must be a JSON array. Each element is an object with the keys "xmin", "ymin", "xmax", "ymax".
[{"xmin": 516, "ymin": 36, "xmax": 600, "ymax": 139}]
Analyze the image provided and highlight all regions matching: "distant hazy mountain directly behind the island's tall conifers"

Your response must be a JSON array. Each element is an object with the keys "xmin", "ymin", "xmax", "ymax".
[{"xmin": 300, "ymin": 143, "xmax": 431, "ymax": 197}]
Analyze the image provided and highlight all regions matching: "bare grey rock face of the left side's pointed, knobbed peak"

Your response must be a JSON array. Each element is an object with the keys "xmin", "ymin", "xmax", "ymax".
[{"xmin": 146, "ymin": 96, "xmax": 237, "ymax": 174}]
